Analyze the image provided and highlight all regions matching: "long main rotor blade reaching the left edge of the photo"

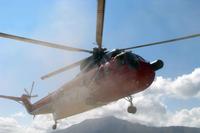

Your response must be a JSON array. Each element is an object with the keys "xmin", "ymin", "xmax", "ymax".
[{"xmin": 0, "ymin": 32, "xmax": 92, "ymax": 53}]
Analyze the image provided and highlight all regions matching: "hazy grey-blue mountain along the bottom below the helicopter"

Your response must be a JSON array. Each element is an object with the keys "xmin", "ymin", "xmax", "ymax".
[{"xmin": 54, "ymin": 117, "xmax": 200, "ymax": 133}]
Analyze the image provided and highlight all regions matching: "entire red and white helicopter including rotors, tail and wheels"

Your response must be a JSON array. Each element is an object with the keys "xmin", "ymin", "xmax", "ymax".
[{"xmin": 0, "ymin": 0, "xmax": 200, "ymax": 129}]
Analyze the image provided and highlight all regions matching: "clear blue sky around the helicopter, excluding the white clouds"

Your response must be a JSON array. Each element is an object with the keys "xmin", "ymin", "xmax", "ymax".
[{"xmin": 0, "ymin": 0, "xmax": 200, "ymax": 131}]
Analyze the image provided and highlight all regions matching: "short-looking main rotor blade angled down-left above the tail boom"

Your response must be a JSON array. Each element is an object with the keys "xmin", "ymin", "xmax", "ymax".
[{"xmin": 41, "ymin": 59, "xmax": 85, "ymax": 80}]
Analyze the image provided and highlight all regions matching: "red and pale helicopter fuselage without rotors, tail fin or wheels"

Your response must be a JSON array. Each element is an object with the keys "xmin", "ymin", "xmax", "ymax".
[{"xmin": 31, "ymin": 51, "xmax": 162, "ymax": 120}]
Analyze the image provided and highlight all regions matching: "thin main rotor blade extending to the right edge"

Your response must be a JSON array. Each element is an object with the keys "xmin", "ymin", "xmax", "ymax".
[{"xmin": 120, "ymin": 34, "xmax": 200, "ymax": 50}]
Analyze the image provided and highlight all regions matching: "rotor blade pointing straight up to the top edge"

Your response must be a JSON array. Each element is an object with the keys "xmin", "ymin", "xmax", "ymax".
[{"xmin": 96, "ymin": 0, "xmax": 105, "ymax": 49}]
